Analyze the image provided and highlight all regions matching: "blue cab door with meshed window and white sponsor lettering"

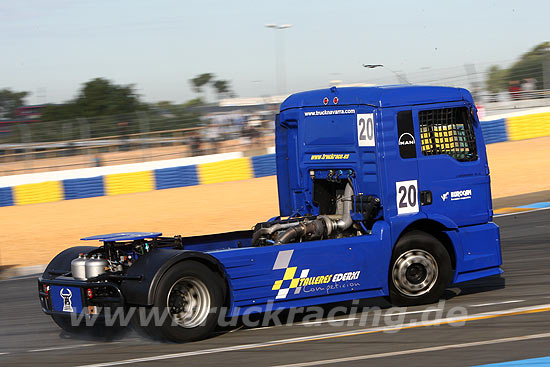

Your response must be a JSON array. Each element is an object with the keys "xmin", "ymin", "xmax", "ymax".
[{"xmin": 414, "ymin": 104, "xmax": 492, "ymax": 226}]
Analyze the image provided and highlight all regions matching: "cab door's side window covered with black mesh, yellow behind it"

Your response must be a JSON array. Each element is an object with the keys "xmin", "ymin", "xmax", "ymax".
[{"xmin": 418, "ymin": 107, "xmax": 477, "ymax": 162}]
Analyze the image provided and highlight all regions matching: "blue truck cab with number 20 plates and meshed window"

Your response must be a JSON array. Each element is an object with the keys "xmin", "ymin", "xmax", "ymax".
[{"xmin": 276, "ymin": 86, "xmax": 501, "ymax": 282}]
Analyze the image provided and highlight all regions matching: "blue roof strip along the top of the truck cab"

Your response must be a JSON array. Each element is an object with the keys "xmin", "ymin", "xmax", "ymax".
[{"xmin": 281, "ymin": 85, "xmax": 472, "ymax": 111}]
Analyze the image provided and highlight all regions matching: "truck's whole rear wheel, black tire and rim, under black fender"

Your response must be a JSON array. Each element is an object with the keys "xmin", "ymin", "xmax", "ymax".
[{"xmin": 133, "ymin": 261, "xmax": 225, "ymax": 343}]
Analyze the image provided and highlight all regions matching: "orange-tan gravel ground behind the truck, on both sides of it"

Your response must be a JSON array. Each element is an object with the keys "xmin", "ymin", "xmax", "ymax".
[{"xmin": 0, "ymin": 137, "xmax": 550, "ymax": 266}]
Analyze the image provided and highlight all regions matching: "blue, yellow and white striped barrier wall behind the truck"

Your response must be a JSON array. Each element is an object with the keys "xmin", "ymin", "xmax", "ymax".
[{"xmin": 0, "ymin": 112, "xmax": 550, "ymax": 206}]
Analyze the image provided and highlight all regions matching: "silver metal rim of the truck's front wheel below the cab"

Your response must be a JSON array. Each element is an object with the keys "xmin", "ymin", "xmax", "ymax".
[{"xmin": 392, "ymin": 249, "xmax": 439, "ymax": 297}]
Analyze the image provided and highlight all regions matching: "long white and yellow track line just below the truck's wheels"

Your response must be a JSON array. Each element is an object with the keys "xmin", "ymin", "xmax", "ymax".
[{"xmin": 74, "ymin": 304, "xmax": 550, "ymax": 367}]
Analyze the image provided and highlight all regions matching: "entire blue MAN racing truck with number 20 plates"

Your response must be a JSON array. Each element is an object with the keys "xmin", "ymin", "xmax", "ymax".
[{"xmin": 38, "ymin": 86, "xmax": 502, "ymax": 341}]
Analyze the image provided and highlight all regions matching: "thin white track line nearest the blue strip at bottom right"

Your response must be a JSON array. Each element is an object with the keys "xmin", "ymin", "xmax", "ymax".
[{"xmin": 274, "ymin": 333, "xmax": 550, "ymax": 367}]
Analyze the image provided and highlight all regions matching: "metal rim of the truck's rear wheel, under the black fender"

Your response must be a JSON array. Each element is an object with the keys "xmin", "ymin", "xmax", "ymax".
[{"xmin": 166, "ymin": 277, "xmax": 211, "ymax": 328}]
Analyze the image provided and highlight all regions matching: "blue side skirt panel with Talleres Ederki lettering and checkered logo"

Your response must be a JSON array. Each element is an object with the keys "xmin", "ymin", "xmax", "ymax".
[{"xmin": 209, "ymin": 222, "xmax": 392, "ymax": 316}]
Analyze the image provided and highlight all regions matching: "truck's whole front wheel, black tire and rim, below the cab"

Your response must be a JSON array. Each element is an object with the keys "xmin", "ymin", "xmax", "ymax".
[{"xmin": 389, "ymin": 231, "xmax": 452, "ymax": 306}]
